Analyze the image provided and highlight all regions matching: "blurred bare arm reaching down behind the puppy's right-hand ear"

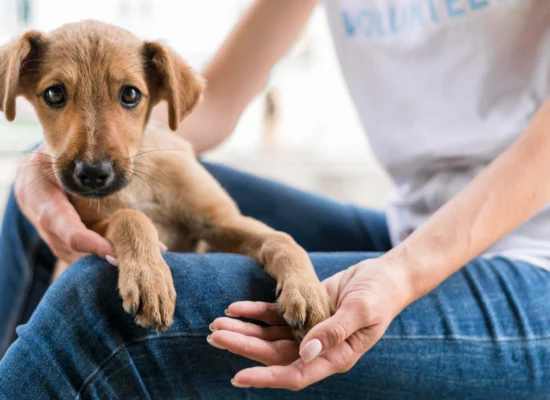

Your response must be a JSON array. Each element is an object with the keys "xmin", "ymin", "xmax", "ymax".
[{"xmin": 153, "ymin": 0, "xmax": 317, "ymax": 152}]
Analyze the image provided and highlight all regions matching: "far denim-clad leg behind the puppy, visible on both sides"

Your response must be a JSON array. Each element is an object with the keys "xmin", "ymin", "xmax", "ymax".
[{"xmin": 0, "ymin": 164, "xmax": 390, "ymax": 357}]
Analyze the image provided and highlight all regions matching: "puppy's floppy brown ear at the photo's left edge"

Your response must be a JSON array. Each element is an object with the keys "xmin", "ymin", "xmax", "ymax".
[{"xmin": 0, "ymin": 31, "xmax": 46, "ymax": 121}]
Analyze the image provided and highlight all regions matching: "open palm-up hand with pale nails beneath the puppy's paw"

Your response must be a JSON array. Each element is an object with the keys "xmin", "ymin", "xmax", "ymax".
[{"xmin": 207, "ymin": 260, "xmax": 411, "ymax": 390}]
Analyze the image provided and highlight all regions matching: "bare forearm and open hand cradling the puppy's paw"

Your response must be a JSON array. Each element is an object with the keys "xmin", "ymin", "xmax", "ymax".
[{"xmin": 208, "ymin": 101, "xmax": 550, "ymax": 390}]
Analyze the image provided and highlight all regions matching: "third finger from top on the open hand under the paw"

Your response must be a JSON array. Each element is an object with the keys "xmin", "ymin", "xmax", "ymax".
[{"xmin": 207, "ymin": 331, "xmax": 298, "ymax": 365}]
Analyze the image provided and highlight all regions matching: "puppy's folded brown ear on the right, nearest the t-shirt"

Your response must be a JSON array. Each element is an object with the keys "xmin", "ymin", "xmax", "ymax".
[{"xmin": 143, "ymin": 42, "xmax": 204, "ymax": 131}]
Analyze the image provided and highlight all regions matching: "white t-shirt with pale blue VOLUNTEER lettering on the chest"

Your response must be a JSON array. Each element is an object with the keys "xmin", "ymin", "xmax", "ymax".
[{"xmin": 325, "ymin": 0, "xmax": 550, "ymax": 269}]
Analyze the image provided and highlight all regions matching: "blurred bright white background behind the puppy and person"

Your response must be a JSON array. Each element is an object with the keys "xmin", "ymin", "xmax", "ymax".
[{"xmin": 0, "ymin": 0, "xmax": 391, "ymax": 219}]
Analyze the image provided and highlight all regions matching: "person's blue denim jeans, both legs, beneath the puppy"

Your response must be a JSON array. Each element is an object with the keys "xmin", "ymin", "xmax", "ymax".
[{"xmin": 0, "ymin": 165, "xmax": 550, "ymax": 400}]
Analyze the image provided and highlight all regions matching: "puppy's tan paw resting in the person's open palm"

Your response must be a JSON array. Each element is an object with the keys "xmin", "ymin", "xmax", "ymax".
[{"xmin": 277, "ymin": 276, "xmax": 334, "ymax": 340}]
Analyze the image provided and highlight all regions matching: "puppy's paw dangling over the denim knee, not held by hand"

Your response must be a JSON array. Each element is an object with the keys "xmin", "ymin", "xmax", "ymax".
[{"xmin": 118, "ymin": 256, "xmax": 176, "ymax": 331}]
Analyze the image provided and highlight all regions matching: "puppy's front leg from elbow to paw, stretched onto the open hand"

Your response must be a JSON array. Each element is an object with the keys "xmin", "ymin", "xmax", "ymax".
[{"xmin": 201, "ymin": 214, "xmax": 333, "ymax": 340}]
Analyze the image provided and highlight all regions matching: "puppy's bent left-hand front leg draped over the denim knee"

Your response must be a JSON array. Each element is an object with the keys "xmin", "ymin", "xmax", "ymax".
[{"xmin": 92, "ymin": 209, "xmax": 176, "ymax": 331}]
